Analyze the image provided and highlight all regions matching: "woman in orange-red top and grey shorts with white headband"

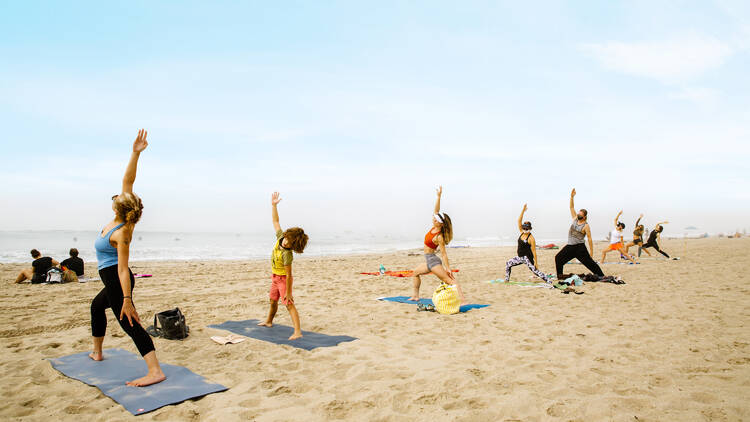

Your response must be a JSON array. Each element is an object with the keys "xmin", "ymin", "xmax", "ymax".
[{"xmin": 409, "ymin": 186, "xmax": 466, "ymax": 305}]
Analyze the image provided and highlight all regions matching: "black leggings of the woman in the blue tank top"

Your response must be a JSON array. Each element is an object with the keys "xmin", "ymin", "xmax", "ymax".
[{"xmin": 91, "ymin": 265, "xmax": 155, "ymax": 356}]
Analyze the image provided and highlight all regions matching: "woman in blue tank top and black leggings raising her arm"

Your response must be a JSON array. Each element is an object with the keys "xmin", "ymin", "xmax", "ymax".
[{"xmin": 89, "ymin": 129, "xmax": 166, "ymax": 387}]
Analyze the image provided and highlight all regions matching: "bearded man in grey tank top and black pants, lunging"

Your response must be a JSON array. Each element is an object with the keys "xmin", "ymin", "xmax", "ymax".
[{"xmin": 555, "ymin": 189, "xmax": 604, "ymax": 279}]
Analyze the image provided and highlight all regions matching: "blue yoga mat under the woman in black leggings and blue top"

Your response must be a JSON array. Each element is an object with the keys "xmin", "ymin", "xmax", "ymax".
[{"xmin": 49, "ymin": 349, "xmax": 227, "ymax": 415}]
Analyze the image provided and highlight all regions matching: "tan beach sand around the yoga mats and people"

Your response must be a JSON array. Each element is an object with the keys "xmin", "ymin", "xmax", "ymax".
[{"xmin": 0, "ymin": 238, "xmax": 750, "ymax": 421}]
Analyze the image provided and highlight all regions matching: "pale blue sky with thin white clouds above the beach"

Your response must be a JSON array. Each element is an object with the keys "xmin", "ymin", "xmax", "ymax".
[{"xmin": 0, "ymin": 1, "xmax": 750, "ymax": 237}]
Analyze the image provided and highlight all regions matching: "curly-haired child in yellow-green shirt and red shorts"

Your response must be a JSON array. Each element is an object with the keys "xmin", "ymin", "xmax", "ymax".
[{"xmin": 258, "ymin": 192, "xmax": 308, "ymax": 340}]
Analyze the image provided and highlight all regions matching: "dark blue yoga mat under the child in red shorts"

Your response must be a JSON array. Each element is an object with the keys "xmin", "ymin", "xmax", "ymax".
[{"xmin": 209, "ymin": 319, "xmax": 357, "ymax": 350}]
